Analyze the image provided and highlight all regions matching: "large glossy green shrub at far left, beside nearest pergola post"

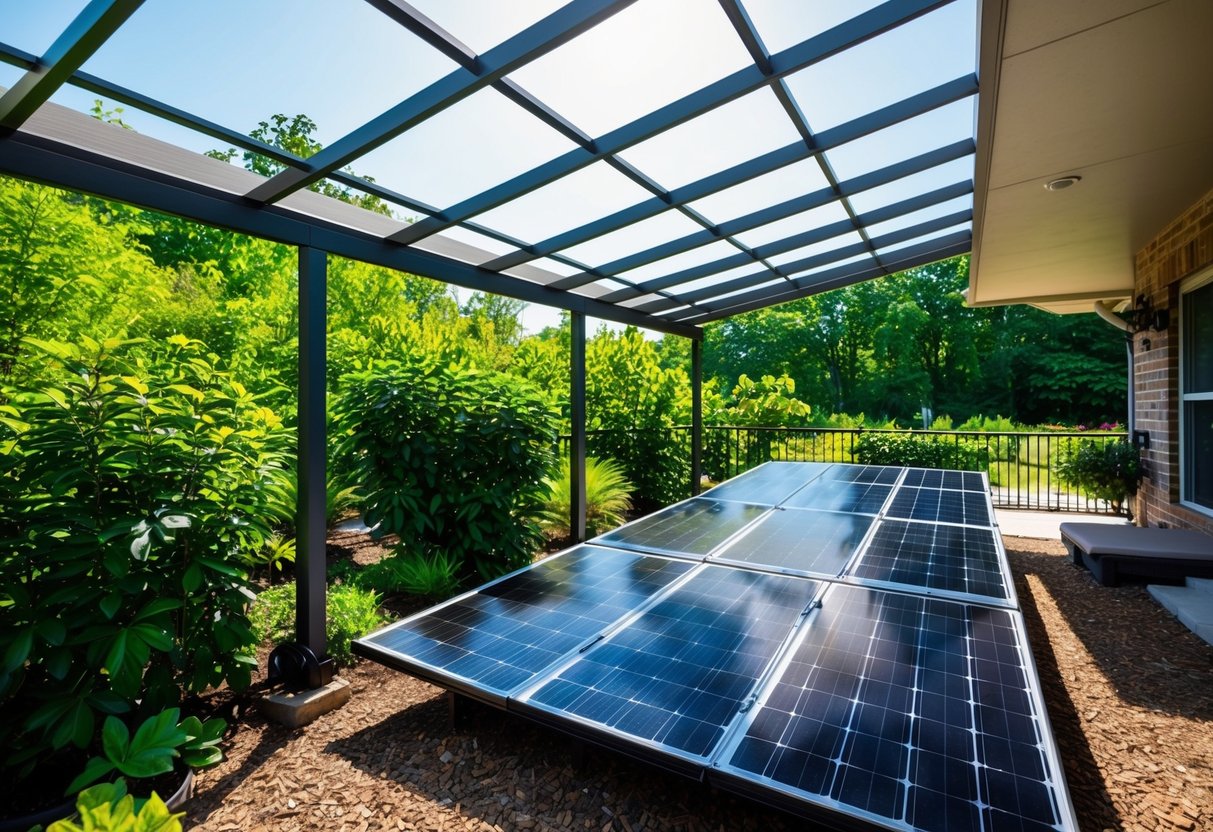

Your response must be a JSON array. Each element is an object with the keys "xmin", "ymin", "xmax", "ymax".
[{"xmin": 0, "ymin": 337, "xmax": 287, "ymax": 797}]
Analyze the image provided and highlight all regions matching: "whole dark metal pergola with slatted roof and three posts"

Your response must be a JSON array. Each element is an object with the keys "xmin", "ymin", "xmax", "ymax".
[{"xmin": 0, "ymin": 0, "xmax": 978, "ymax": 684}]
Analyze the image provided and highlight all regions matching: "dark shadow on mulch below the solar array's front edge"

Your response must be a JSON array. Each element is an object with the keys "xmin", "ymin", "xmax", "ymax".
[{"xmin": 325, "ymin": 696, "xmax": 804, "ymax": 832}]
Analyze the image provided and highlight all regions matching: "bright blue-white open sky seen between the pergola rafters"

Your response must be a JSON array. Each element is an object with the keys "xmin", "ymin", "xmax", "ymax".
[{"xmin": 0, "ymin": 0, "xmax": 976, "ymax": 330}]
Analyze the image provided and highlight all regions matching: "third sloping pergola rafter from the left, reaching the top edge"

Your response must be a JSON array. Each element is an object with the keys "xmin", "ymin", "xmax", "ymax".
[{"xmin": 393, "ymin": 0, "xmax": 951, "ymax": 243}]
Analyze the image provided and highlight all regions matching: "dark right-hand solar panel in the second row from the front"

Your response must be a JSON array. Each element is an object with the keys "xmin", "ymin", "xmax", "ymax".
[{"xmin": 848, "ymin": 519, "xmax": 1014, "ymax": 604}]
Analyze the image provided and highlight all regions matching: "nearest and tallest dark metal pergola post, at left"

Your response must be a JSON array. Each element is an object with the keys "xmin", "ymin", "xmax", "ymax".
[{"xmin": 295, "ymin": 247, "xmax": 328, "ymax": 656}]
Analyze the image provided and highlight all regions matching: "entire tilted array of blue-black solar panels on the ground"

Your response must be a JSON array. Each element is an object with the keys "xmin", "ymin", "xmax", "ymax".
[{"xmin": 354, "ymin": 462, "xmax": 1077, "ymax": 832}]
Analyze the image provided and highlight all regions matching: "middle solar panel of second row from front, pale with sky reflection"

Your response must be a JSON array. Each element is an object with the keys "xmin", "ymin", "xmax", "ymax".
[{"xmin": 712, "ymin": 508, "xmax": 875, "ymax": 577}]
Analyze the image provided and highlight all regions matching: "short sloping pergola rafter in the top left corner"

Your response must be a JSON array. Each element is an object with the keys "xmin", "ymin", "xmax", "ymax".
[{"xmin": 0, "ymin": 0, "xmax": 143, "ymax": 133}]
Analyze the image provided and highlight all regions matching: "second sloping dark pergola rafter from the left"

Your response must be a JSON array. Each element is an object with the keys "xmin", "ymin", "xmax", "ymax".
[{"xmin": 246, "ymin": 0, "xmax": 636, "ymax": 203}]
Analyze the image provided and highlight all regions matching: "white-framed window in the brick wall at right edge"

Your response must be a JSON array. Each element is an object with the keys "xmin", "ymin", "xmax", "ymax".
[{"xmin": 1179, "ymin": 270, "xmax": 1213, "ymax": 509}]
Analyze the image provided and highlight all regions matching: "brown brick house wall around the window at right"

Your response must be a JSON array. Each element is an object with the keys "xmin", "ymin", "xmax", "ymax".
[{"xmin": 1133, "ymin": 186, "xmax": 1213, "ymax": 532}]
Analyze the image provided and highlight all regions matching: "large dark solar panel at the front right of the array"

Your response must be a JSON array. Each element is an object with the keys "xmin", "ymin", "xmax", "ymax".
[{"xmin": 710, "ymin": 585, "xmax": 1077, "ymax": 832}]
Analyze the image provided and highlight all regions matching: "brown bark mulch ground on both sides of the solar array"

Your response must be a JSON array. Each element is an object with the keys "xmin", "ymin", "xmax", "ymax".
[{"xmin": 187, "ymin": 537, "xmax": 1213, "ymax": 832}]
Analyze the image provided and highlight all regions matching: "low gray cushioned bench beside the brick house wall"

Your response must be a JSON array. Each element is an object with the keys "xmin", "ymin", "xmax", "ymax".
[{"xmin": 1061, "ymin": 523, "xmax": 1213, "ymax": 587}]
